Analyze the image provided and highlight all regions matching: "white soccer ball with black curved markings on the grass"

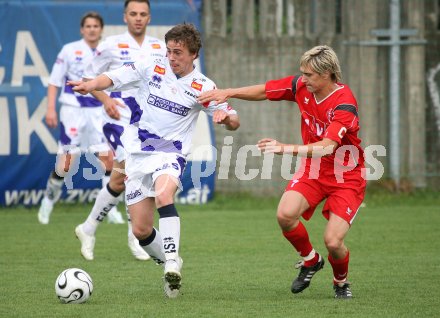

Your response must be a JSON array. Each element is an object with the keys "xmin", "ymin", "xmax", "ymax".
[{"xmin": 55, "ymin": 268, "xmax": 93, "ymax": 304}]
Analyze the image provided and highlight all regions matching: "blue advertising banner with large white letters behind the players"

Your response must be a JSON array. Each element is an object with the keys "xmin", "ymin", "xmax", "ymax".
[{"xmin": 0, "ymin": 0, "xmax": 216, "ymax": 206}]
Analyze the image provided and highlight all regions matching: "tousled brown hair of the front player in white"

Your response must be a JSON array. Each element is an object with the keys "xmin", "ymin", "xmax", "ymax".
[{"xmin": 165, "ymin": 23, "xmax": 202, "ymax": 57}]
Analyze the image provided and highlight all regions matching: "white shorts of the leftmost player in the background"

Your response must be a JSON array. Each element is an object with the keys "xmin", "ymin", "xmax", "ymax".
[{"xmin": 58, "ymin": 105, "xmax": 110, "ymax": 153}]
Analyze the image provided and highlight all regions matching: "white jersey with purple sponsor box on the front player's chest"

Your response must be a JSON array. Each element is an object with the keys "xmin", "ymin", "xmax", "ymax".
[{"xmin": 104, "ymin": 58, "xmax": 236, "ymax": 158}]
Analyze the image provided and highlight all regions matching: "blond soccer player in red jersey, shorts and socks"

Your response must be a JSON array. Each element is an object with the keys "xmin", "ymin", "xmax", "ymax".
[{"xmin": 199, "ymin": 45, "xmax": 366, "ymax": 299}]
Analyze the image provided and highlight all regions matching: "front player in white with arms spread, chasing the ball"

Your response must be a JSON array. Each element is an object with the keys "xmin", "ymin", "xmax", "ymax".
[{"xmin": 70, "ymin": 24, "xmax": 240, "ymax": 298}]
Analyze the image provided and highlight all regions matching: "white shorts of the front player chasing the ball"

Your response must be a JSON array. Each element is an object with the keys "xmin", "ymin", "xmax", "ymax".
[{"xmin": 125, "ymin": 153, "xmax": 186, "ymax": 205}]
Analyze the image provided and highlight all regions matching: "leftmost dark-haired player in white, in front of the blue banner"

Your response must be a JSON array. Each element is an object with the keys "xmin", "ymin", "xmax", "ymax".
[{"xmin": 38, "ymin": 12, "xmax": 112, "ymax": 224}]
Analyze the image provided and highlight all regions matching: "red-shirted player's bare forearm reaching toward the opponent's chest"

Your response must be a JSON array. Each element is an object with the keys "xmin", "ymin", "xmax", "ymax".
[{"xmin": 197, "ymin": 84, "xmax": 266, "ymax": 104}]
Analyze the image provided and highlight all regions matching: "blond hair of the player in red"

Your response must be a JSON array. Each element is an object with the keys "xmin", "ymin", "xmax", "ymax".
[{"xmin": 300, "ymin": 45, "xmax": 342, "ymax": 82}]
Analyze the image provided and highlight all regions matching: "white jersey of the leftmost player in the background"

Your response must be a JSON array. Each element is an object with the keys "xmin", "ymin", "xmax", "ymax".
[{"xmin": 49, "ymin": 39, "xmax": 102, "ymax": 107}]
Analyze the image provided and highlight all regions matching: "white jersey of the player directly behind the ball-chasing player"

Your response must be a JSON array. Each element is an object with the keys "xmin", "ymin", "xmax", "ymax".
[{"xmin": 83, "ymin": 32, "xmax": 166, "ymax": 125}]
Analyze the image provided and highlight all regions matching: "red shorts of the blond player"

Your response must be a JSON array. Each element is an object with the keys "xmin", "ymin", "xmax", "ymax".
[{"xmin": 285, "ymin": 160, "xmax": 367, "ymax": 225}]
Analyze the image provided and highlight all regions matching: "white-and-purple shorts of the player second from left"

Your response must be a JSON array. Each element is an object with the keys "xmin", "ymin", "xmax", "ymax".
[{"xmin": 102, "ymin": 106, "xmax": 131, "ymax": 162}]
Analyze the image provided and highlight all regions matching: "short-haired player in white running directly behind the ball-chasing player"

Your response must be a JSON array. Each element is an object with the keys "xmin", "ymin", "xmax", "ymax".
[{"xmin": 75, "ymin": 0, "xmax": 166, "ymax": 260}]
